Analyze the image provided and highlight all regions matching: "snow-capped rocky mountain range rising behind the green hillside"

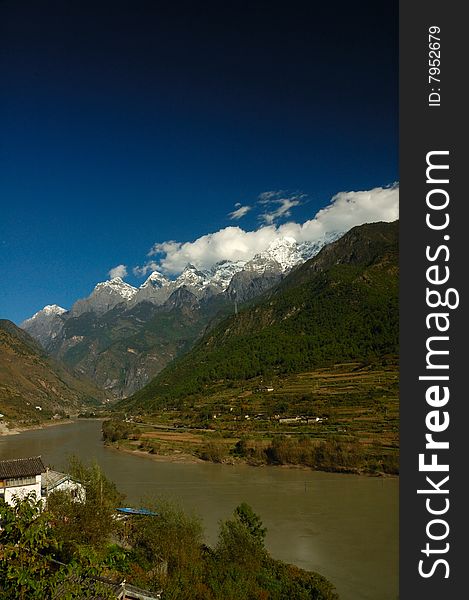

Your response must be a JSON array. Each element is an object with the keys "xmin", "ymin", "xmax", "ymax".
[{"xmin": 22, "ymin": 233, "xmax": 350, "ymax": 398}]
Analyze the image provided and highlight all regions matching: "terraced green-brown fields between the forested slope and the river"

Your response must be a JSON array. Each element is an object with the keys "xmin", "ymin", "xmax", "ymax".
[{"xmin": 107, "ymin": 356, "xmax": 399, "ymax": 474}]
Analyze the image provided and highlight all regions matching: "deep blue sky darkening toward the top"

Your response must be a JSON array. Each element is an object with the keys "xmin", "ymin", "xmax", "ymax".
[{"xmin": 0, "ymin": 0, "xmax": 398, "ymax": 322}]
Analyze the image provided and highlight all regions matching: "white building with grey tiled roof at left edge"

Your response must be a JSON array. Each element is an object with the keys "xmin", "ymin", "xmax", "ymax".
[{"xmin": 0, "ymin": 456, "xmax": 46, "ymax": 505}]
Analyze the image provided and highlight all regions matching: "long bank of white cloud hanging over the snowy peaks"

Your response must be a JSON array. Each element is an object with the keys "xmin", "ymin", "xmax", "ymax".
[{"xmin": 133, "ymin": 184, "xmax": 399, "ymax": 274}]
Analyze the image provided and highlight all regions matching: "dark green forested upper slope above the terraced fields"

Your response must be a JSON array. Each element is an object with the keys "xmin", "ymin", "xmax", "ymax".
[{"xmin": 119, "ymin": 222, "xmax": 398, "ymax": 412}]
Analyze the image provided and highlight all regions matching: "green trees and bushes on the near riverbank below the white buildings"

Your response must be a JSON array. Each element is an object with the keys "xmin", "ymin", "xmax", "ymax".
[{"xmin": 0, "ymin": 460, "xmax": 338, "ymax": 600}]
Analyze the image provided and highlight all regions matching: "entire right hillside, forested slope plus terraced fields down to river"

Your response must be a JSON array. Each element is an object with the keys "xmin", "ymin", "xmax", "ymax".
[{"xmin": 110, "ymin": 222, "xmax": 399, "ymax": 474}]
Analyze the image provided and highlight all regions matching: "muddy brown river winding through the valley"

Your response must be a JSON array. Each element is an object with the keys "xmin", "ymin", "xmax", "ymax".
[{"xmin": 0, "ymin": 420, "xmax": 399, "ymax": 600}]
